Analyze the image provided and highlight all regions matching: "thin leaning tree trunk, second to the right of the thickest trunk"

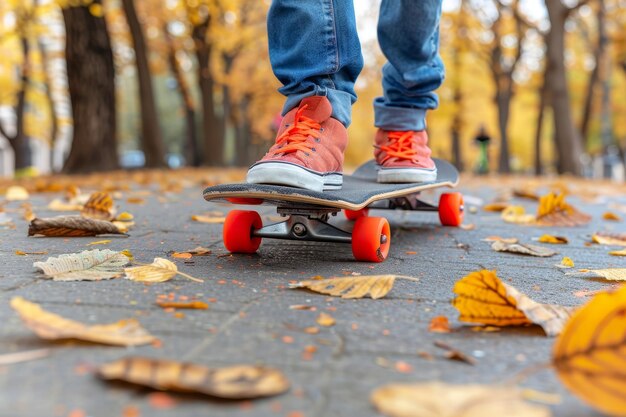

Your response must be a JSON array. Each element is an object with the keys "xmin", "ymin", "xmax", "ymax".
[{"xmin": 163, "ymin": 25, "xmax": 200, "ymax": 166}]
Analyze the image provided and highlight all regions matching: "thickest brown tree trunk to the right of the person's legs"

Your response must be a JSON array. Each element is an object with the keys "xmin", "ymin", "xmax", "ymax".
[{"xmin": 546, "ymin": 0, "xmax": 583, "ymax": 175}]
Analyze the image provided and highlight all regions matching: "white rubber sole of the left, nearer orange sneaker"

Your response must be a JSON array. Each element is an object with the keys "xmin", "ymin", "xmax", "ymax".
[{"xmin": 246, "ymin": 162, "xmax": 343, "ymax": 192}]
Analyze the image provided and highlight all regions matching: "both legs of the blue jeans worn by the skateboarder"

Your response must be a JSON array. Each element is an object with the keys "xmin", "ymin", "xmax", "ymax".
[{"xmin": 267, "ymin": 0, "xmax": 444, "ymax": 131}]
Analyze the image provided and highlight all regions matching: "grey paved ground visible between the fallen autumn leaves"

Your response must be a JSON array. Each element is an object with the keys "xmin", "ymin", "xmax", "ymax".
[{"xmin": 0, "ymin": 173, "xmax": 626, "ymax": 417}]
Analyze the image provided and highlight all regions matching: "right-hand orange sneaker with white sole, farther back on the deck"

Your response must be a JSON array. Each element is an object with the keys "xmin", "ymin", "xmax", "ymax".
[{"xmin": 374, "ymin": 129, "xmax": 437, "ymax": 183}]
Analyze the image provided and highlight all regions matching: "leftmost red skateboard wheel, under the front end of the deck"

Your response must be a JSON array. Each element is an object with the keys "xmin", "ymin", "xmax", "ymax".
[{"xmin": 222, "ymin": 210, "xmax": 263, "ymax": 253}]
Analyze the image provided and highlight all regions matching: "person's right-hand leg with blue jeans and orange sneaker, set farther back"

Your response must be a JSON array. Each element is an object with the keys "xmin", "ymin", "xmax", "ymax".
[{"xmin": 374, "ymin": 0, "xmax": 444, "ymax": 182}]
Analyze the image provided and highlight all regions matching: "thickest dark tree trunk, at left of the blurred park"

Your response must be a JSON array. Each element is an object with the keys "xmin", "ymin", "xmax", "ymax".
[{"xmin": 63, "ymin": 0, "xmax": 118, "ymax": 173}]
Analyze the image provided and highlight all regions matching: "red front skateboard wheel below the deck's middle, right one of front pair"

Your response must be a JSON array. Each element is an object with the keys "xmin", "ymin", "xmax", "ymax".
[{"xmin": 352, "ymin": 217, "xmax": 391, "ymax": 262}]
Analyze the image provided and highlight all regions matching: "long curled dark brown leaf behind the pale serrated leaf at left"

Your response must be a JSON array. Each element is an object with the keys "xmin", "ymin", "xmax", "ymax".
[{"xmin": 28, "ymin": 216, "xmax": 123, "ymax": 237}]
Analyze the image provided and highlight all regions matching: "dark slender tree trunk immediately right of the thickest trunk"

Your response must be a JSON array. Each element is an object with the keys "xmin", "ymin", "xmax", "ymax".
[{"xmin": 122, "ymin": 0, "xmax": 165, "ymax": 168}]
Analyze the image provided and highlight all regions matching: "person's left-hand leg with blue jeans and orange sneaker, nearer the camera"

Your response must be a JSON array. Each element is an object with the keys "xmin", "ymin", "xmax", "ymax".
[{"xmin": 246, "ymin": 0, "xmax": 363, "ymax": 191}]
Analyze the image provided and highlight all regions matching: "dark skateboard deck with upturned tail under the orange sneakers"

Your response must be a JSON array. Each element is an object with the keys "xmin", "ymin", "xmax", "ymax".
[{"xmin": 204, "ymin": 159, "xmax": 459, "ymax": 210}]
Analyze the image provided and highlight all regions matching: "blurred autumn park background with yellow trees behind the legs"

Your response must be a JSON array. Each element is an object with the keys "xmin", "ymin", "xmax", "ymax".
[{"xmin": 0, "ymin": 0, "xmax": 626, "ymax": 181}]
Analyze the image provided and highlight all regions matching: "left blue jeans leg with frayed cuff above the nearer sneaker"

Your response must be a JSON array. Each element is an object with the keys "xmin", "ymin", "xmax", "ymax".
[{"xmin": 267, "ymin": 0, "xmax": 363, "ymax": 127}]
